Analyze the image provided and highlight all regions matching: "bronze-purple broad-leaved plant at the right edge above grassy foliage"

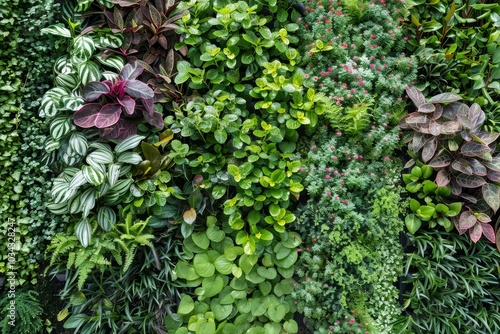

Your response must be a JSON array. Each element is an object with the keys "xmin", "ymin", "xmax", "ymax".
[{"xmin": 399, "ymin": 86, "xmax": 500, "ymax": 248}]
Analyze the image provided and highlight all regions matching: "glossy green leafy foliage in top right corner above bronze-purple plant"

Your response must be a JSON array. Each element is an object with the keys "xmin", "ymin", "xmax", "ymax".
[{"xmin": 406, "ymin": 0, "xmax": 500, "ymax": 131}]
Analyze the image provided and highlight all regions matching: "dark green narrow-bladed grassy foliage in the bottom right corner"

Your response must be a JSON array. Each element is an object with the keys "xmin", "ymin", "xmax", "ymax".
[{"xmin": 395, "ymin": 231, "xmax": 500, "ymax": 334}]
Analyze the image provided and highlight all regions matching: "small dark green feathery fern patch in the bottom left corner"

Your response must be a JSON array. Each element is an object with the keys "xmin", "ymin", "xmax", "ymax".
[{"xmin": 0, "ymin": 289, "xmax": 44, "ymax": 334}]
